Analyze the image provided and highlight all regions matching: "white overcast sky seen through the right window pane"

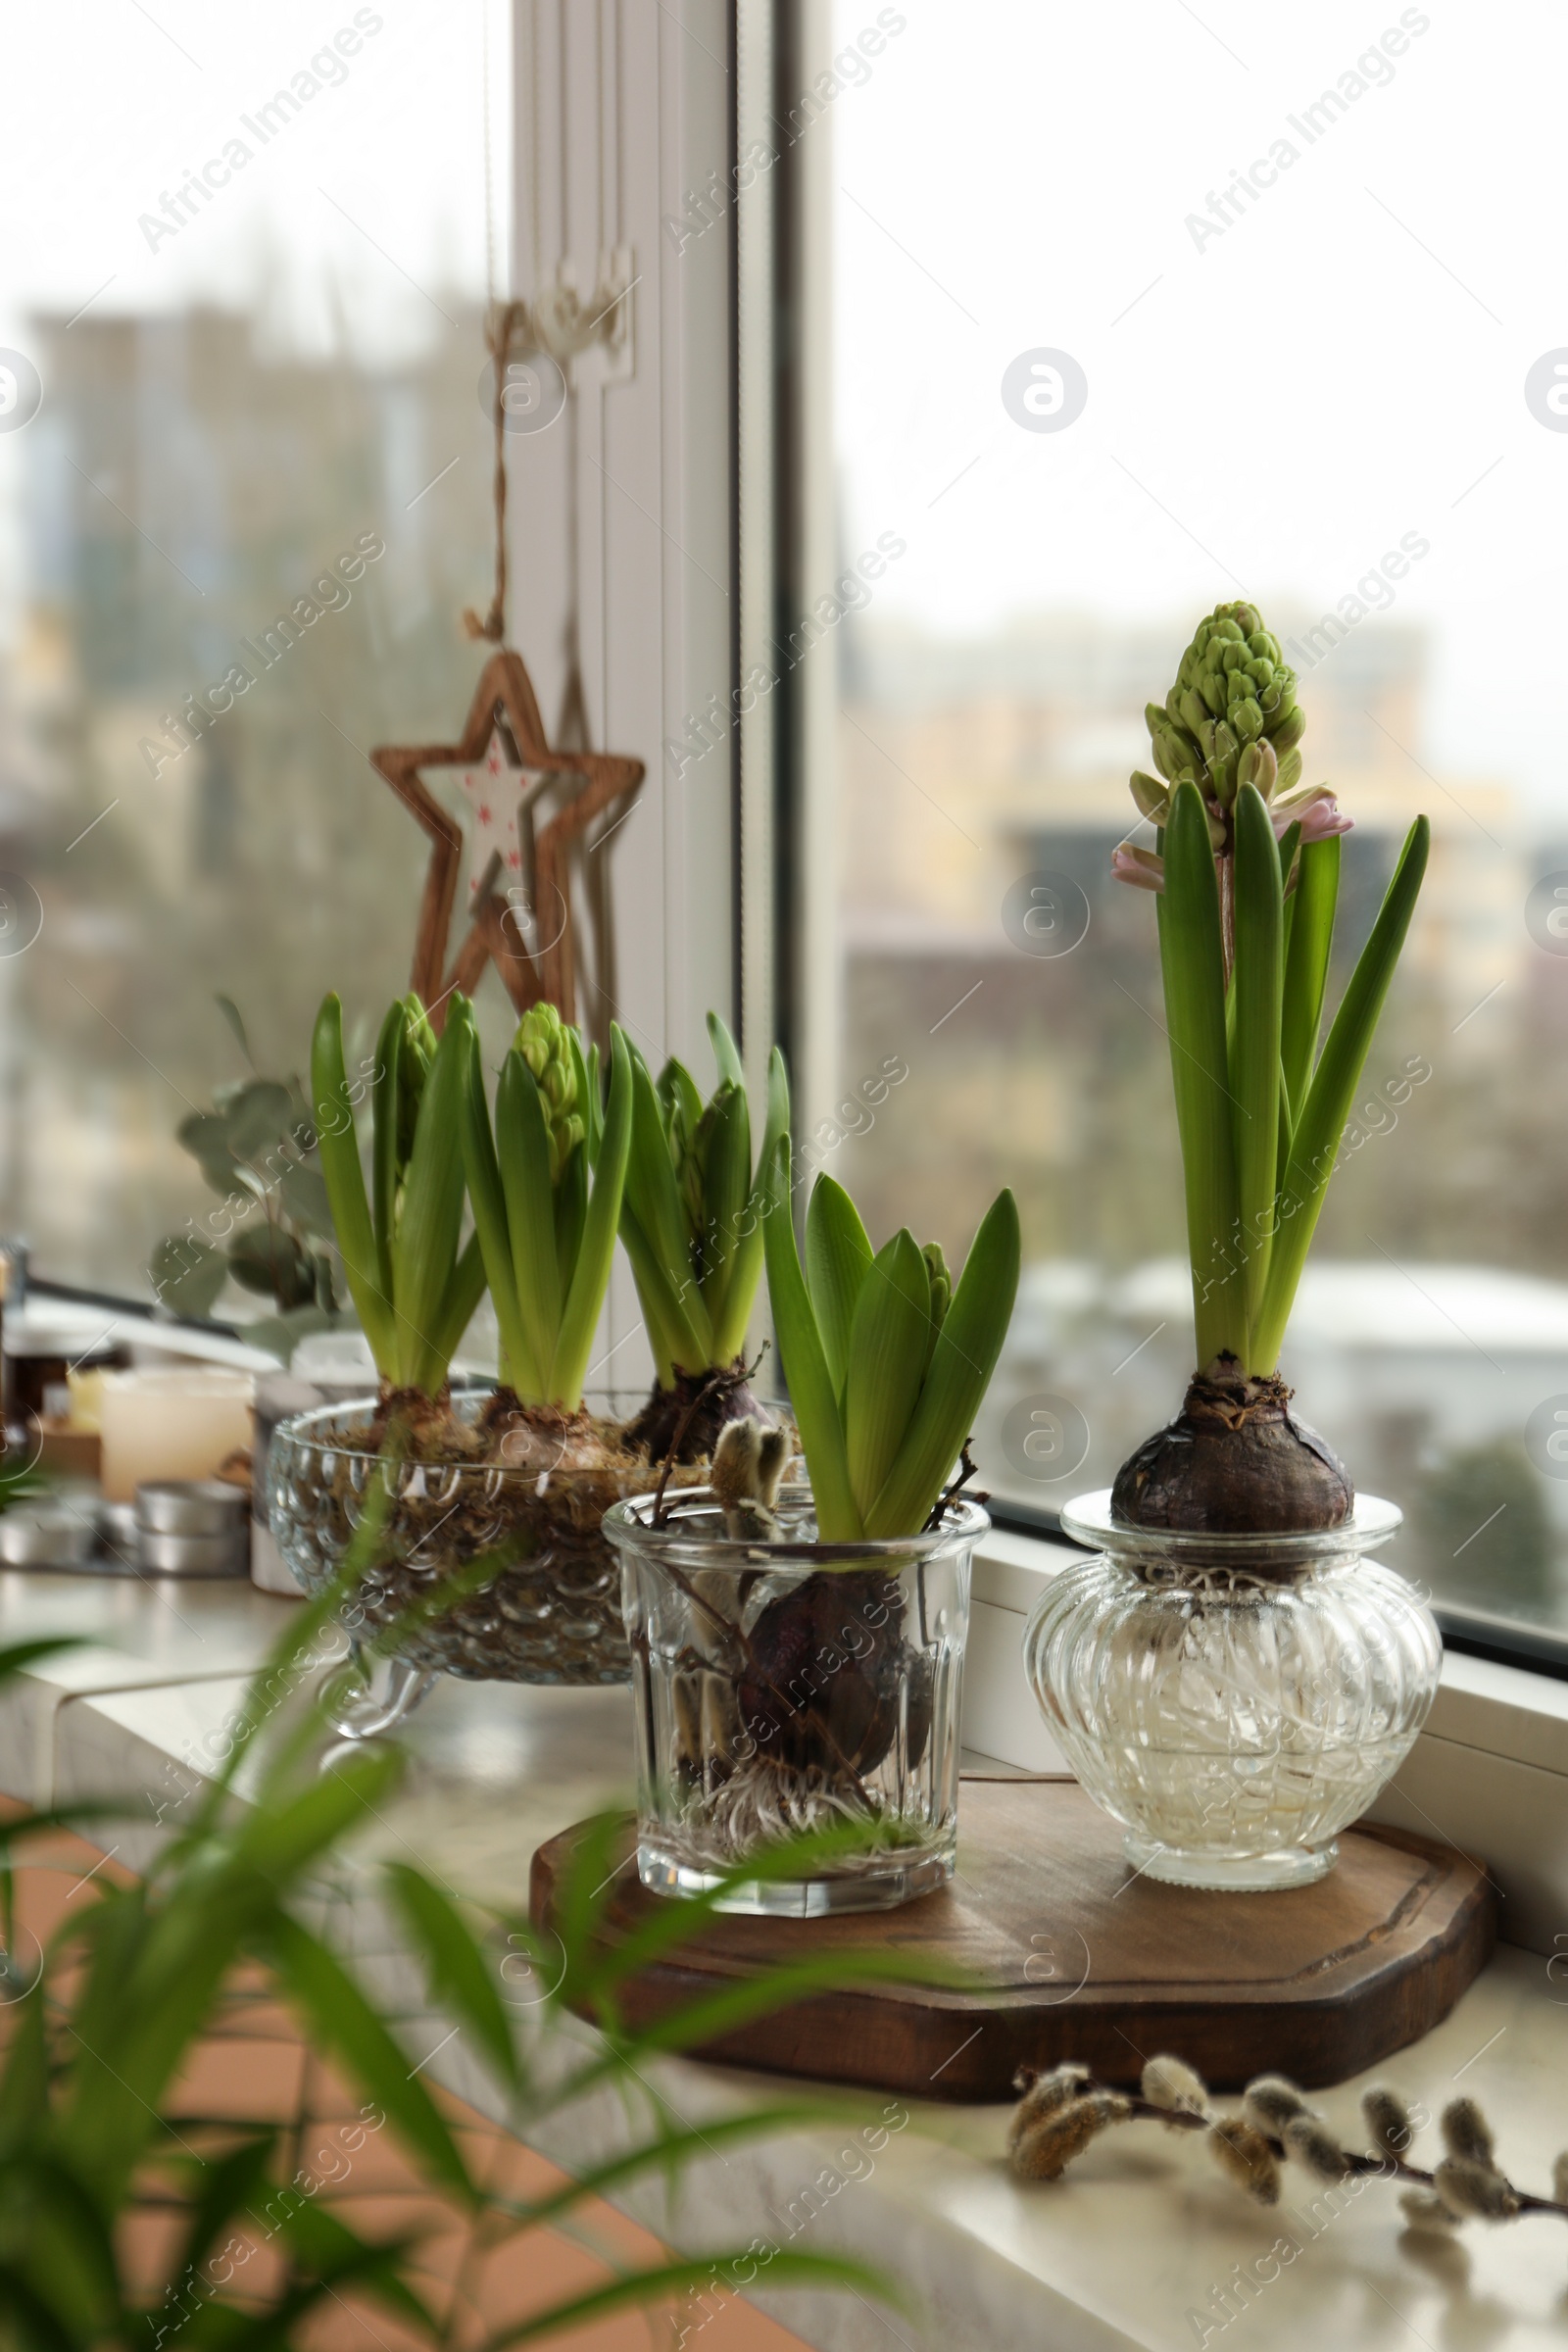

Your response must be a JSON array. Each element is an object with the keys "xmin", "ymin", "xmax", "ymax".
[{"xmin": 832, "ymin": 0, "xmax": 1568, "ymax": 798}]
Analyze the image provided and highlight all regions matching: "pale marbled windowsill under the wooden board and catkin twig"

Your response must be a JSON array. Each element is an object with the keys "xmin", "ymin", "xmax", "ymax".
[{"xmin": 0, "ymin": 1571, "xmax": 1568, "ymax": 2352}]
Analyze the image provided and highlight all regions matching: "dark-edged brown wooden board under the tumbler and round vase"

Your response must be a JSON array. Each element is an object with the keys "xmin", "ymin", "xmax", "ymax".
[{"xmin": 531, "ymin": 1781, "xmax": 1497, "ymax": 2100}]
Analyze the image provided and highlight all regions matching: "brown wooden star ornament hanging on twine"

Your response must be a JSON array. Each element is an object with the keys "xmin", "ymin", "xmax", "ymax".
[{"xmin": 371, "ymin": 652, "xmax": 644, "ymax": 1030}]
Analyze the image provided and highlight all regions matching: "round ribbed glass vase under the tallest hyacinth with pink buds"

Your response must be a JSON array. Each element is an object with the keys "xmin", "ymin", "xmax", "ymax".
[{"xmin": 1022, "ymin": 1492, "xmax": 1441, "ymax": 1888}]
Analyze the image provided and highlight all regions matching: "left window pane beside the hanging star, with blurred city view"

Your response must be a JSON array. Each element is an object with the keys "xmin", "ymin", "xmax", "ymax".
[{"xmin": 0, "ymin": 0, "xmax": 508, "ymax": 1305}]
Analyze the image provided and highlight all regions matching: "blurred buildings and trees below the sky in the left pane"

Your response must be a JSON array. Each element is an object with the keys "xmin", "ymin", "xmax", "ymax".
[{"xmin": 0, "ymin": 294, "xmax": 491, "ymax": 1312}]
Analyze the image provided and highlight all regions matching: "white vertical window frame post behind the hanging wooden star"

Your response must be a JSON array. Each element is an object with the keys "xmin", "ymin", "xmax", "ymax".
[{"xmin": 508, "ymin": 0, "xmax": 738, "ymax": 1388}]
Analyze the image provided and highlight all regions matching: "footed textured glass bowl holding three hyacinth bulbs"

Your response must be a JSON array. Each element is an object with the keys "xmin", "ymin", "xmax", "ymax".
[{"xmin": 268, "ymin": 1383, "xmax": 696, "ymax": 1739}]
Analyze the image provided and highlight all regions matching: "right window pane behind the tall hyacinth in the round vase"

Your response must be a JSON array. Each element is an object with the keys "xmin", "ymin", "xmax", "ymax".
[{"xmin": 817, "ymin": 0, "xmax": 1568, "ymax": 1628}]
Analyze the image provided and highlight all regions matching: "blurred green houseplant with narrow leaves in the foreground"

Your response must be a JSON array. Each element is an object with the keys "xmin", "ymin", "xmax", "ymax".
[{"xmin": 0, "ymin": 1510, "xmax": 898, "ymax": 2352}]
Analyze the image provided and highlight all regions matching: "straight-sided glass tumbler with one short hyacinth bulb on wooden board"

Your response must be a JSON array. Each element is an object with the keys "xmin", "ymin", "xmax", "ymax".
[{"xmin": 604, "ymin": 1484, "xmax": 990, "ymax": 1919}]
